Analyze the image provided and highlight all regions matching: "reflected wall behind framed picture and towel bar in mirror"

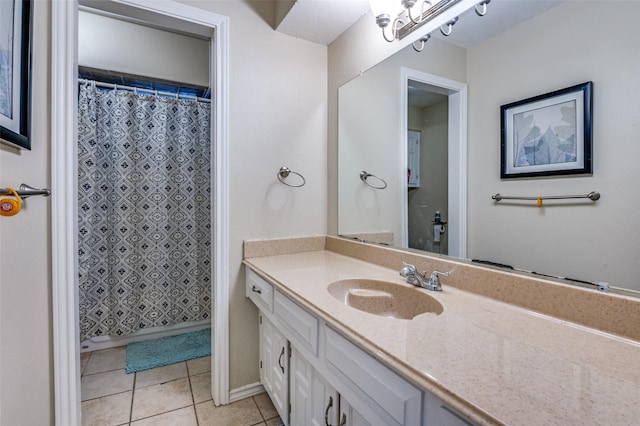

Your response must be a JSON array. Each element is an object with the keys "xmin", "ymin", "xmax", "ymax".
[{"xmin": 467, "ymin": 1, "xmax": 640, "ymax": 290}]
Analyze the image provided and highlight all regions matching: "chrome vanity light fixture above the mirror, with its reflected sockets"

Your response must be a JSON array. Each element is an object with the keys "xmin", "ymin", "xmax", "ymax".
[{"xmin": 369, "ymin": 0, "xmax": 491, "ymax": 44}]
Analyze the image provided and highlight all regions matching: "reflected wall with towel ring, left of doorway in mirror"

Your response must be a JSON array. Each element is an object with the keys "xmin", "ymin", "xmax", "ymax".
[{"xmin": 338, "ymin": 62, "xmax": 406, "ymax": 246}]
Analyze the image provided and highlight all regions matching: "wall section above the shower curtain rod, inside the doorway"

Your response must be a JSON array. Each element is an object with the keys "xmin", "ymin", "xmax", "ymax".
[{"xmin": 78, "ymin": 11, "xmax": 209, "ymax": 87}]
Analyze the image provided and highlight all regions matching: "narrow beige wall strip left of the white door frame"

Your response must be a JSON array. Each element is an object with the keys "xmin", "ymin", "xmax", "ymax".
[{"xmin": 0, "ymin": 1, "xmax": 53, "ymax": 426}]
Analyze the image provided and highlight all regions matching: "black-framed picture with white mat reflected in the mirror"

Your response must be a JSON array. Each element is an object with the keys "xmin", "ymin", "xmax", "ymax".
[{"xmin": 500, "ymin": 81, "xmax": 593, "ymax": 179}]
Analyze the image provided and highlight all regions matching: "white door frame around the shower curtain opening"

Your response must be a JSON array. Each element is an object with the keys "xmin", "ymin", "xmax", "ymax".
[{"xmin": 50, "ymin": 0, "xmax": 229, "ymax": 426}]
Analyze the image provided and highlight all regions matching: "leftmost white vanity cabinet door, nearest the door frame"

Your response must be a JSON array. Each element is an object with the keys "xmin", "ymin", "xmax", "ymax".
[{"xmin": 260, "ymin": 315, "xmax": 289, "ymax": 423}]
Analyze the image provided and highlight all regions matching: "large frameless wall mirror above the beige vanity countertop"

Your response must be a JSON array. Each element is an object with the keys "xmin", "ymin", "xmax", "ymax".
[{"xmin": 338, "ymin": 0, "xmax": 640, "ymax": 295}]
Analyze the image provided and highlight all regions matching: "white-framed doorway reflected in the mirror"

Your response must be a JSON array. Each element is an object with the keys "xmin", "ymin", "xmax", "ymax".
[{"xmin": 401, "ymin": 67, "xmax": 467, "ymax": 258}]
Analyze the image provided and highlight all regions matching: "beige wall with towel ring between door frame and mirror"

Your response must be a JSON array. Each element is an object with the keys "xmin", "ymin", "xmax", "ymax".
[{"xmin": 179, "ymin": 1, "xmax": 327, "ymax": 389}]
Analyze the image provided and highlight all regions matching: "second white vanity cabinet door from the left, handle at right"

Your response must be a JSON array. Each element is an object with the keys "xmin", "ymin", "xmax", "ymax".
[{"xmin": 290, "ymin": 347, "xmax": 338, "ymax": 426}]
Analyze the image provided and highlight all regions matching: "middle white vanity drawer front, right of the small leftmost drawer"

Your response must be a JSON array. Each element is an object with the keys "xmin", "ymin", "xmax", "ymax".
[{"xmin": 274, "ymin": 291, "xmax": 318, "ymax": 355}]
